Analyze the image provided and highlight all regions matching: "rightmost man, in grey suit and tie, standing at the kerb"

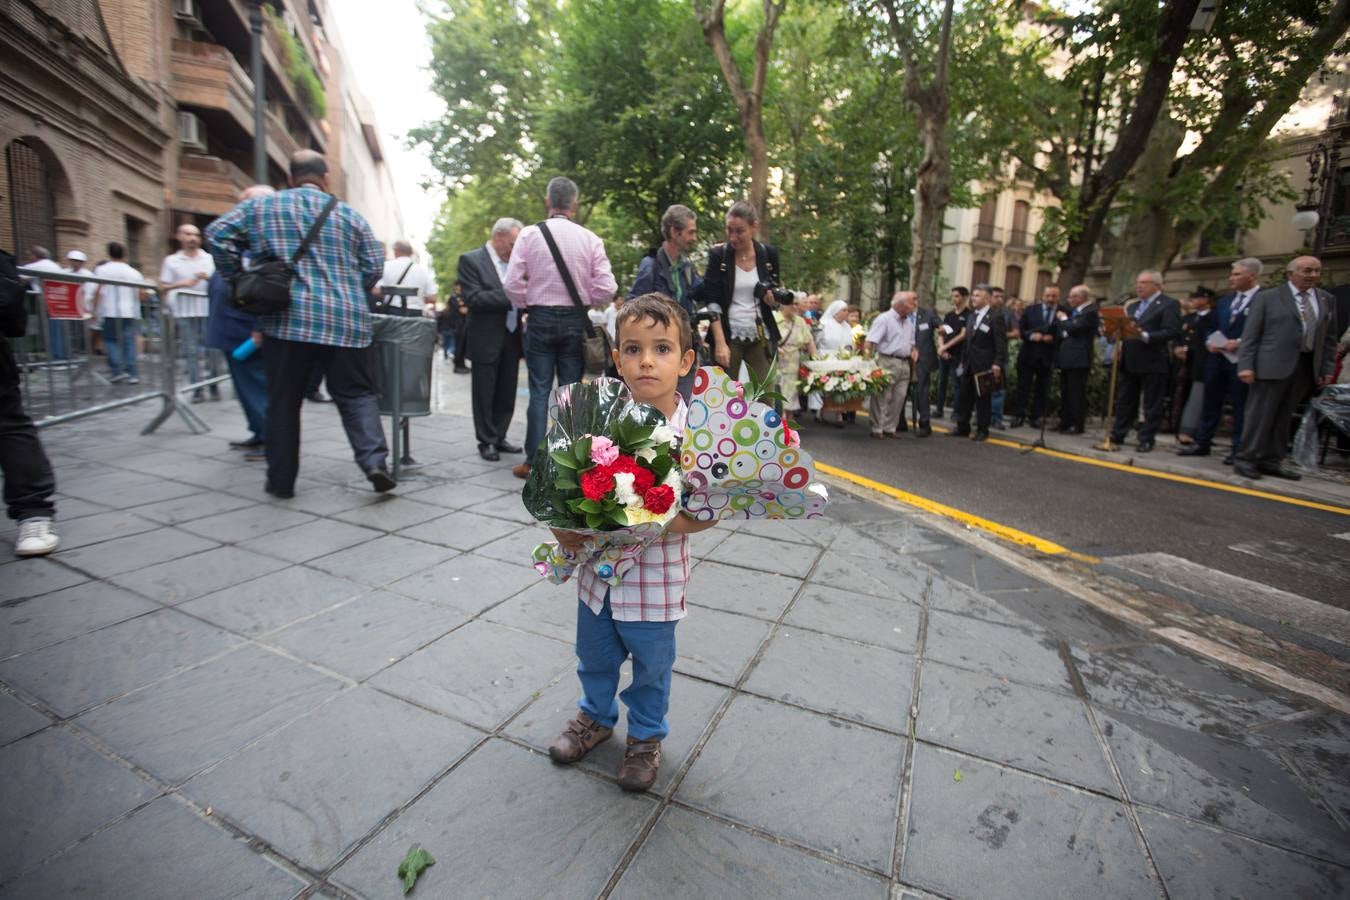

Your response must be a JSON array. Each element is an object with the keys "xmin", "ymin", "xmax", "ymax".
[{"xmin": 1233, "ymin": 256, "xmax": 1338, "ymax": 480}]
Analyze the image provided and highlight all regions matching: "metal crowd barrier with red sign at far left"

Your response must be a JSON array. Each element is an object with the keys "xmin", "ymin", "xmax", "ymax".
[{"xmin": 9, "ymin": 266, "xmax": 213, "ymax": 434}]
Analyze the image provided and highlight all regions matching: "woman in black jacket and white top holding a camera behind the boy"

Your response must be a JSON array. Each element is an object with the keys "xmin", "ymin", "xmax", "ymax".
[{"xmin": 701, "ymin": 200, "xmax": 779, "ymax": 382}]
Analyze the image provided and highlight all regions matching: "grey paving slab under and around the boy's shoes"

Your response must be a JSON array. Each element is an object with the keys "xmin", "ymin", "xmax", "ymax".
[{"xmin": 504, "ymin": 663, "xmax": 728, "ymax": 793}]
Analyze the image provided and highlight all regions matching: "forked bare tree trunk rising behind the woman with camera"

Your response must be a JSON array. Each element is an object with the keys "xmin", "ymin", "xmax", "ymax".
[{"xmin": 694, "ymin": 0, "xmax": 787, "ymax": 229}]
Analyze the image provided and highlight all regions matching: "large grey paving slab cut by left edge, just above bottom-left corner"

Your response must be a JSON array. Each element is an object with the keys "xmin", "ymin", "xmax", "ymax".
[{"xmin": 0, "ymin": 727, "xmax": 159, "ymax": 896}]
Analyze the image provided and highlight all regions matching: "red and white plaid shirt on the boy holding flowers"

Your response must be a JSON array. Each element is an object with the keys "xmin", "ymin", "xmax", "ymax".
[{"xmin": 576, "ymin": 398, "xmax": 689, "ymax": 622}]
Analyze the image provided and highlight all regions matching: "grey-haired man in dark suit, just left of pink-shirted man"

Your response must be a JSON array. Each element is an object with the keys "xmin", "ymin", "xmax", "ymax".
[{"xmin": 451, "ymin": 219, "xmax": 525, "ymax": 463}]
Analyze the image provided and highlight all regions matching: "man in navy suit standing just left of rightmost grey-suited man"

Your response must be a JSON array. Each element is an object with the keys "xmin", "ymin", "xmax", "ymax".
[{"xmin": 1179, "ymin": 256, "xmax": 1265, "ymax": 466}]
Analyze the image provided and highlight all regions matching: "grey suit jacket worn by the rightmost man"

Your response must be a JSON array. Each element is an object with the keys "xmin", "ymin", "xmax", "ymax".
[{"xmin": 1238, "ymin": 282, "xmax": 1339, "ymax": 381}]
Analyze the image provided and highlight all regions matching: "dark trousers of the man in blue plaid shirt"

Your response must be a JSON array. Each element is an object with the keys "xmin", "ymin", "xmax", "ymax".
[{"xmin": 262, "ymin": 337, "xmax": 389, "ymax": 491}]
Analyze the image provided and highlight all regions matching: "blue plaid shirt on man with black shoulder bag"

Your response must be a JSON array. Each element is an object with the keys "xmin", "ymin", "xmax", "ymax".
[{"xmin": 204, "ymin": 185, "xmax": 385, "ymax": 347}]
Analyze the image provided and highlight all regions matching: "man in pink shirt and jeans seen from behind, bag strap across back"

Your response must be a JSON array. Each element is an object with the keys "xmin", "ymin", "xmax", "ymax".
[{"xmin": 502, "ymin": 175, "xmax": 618, "ymax": 478}]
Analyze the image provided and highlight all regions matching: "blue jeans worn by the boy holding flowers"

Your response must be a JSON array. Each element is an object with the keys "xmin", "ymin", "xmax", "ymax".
[{"xmin": 576, "ymin": 595, "xmax": 678, "ymax": 741}]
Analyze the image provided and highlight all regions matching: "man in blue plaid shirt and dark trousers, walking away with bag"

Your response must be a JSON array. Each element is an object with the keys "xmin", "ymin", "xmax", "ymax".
[{"xmin": 205, "ymin": 150, "xmax": 396, "ymax": 498}]
